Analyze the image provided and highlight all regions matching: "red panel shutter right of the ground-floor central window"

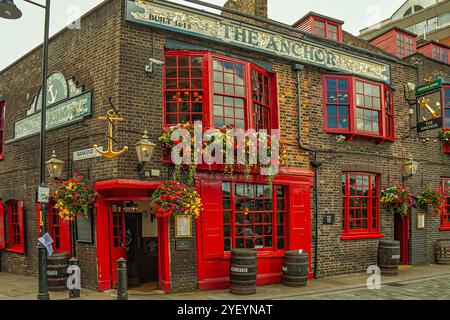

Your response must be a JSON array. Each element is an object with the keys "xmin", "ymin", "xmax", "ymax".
[{"xmin": 288, "ymin": 184, "xmax": 311, "ymax": 252}]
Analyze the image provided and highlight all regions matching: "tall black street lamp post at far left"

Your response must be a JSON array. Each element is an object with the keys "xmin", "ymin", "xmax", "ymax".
[{"xmin": 0, "ymin": 0, "xmax": 50, "ymax": 300}]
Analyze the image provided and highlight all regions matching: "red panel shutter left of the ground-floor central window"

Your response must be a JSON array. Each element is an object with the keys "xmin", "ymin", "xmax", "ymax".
[{"xmin": 200, "ymin": 180, "xmax": 224, "ymax": 259}]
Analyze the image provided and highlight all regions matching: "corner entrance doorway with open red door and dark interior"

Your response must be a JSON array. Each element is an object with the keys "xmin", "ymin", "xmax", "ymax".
[{"xmin": 108, "ymin": 201, "xmax": 158, "ymax": 291}]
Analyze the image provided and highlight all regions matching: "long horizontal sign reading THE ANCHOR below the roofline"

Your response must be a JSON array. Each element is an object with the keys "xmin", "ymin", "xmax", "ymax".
[{"xmin": 126, "ymin": 0, "xmax": 391, "ymax": 83}]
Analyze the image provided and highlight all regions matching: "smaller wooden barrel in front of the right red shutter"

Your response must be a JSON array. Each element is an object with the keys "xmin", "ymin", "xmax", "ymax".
[{"xmin": 283, "ymin": 251, "xmax": 308, "ymax": 287}]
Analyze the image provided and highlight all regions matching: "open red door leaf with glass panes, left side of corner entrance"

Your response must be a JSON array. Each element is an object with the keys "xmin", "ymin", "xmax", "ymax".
[{"xmin": 109, "ymin": 202, "xmax": 127, "ymax": 288}]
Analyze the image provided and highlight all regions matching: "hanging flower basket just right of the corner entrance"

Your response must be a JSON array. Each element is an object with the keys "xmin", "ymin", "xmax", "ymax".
[{"xmin": 150, "ymin": 181, "xmax": 203, "ymax": 218}]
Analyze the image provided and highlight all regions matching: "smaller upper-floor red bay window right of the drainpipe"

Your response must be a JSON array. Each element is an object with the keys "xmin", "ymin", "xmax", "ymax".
[{"xmin": 323, "ymin": 76, "xmax": 394, "ymax": 140}]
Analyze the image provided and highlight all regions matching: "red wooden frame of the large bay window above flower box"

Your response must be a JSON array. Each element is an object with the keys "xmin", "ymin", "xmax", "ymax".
[{"xmin": 163, "ymin": 50, "xmax": 279, "ymax": 129}]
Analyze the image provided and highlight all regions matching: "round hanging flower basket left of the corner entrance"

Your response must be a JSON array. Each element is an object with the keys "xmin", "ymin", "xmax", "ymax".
[{"xmin": 54, "ymin": 173, "xmax": 97, "ymax": 221}]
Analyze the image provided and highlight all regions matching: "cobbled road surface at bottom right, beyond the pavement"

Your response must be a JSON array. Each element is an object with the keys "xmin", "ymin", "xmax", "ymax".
[{"xmin": 276, "ymin": 275, "xmax": 450, "ymax": 300}]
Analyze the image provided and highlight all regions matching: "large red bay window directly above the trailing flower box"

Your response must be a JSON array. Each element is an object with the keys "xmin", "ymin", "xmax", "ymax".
[{"xmin": 164, "ymin": 51, "xmax": 278, "ymax": 130}]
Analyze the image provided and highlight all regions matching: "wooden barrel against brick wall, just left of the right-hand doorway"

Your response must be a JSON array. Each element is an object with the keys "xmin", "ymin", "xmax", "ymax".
[{"xmin": 377, "ymin": 240, "xmax": 400, "ymax": 276}]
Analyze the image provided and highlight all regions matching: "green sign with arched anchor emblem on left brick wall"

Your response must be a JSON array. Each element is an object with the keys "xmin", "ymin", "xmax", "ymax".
[{"xmin": 7, "ymin": 72, "xmax": 92, "ymax": 141}]
